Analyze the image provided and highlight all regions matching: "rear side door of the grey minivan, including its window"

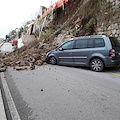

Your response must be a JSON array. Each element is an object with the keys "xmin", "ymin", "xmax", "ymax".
[{"xmin": 73, "ymin": 38, "xmax": 93, "ymax": 66}]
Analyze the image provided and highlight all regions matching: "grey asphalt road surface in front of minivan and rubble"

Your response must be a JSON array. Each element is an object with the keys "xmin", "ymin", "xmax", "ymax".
[{"xmin": 5, "ymin": 65, "xmax": 120, "ymax": 120}]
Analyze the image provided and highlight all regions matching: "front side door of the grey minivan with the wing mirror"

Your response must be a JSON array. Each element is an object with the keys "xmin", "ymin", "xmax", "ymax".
[{"xmin": 56, "ymin": 40, "xmax": 75, "ymax": 65}]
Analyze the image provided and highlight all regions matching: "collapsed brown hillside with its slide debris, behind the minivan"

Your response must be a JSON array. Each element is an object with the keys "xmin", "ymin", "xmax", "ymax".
[{"xmin": 1, "ymin": 0, "xmax": 120, "ymax": 71}]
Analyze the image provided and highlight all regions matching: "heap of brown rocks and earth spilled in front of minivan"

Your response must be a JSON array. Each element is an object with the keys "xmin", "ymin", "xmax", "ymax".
[{"xmin": 0, "ymin": 43, "xmax": 56, "ymax": 72}]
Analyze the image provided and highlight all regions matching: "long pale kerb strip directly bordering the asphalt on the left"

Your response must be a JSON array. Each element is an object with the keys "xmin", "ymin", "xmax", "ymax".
[{"xmin": 1, "ymin": 72, "xmax": 21, "ymax": 120}]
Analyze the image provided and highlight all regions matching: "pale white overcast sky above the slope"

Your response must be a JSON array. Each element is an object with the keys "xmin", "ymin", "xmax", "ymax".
[{"xmin": 0, "ymin": 0, "xmax": 57, "ymax": 38}]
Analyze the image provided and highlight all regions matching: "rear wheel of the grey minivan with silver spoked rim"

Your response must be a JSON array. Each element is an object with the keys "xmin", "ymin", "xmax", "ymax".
[{"xmin": 90, "ymin": 58, "xmax": 104, "ymax": 72}]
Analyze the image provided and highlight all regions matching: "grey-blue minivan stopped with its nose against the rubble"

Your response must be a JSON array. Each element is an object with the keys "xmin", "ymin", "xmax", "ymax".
[{"xmin": 46, "ymin": 35, "xmax": 120, "ymax": 71}]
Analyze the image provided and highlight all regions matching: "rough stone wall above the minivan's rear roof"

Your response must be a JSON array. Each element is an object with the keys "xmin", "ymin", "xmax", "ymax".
[{"xmin": 97, "ymin": 0, "xmax": 120, "ymax": 40}]
